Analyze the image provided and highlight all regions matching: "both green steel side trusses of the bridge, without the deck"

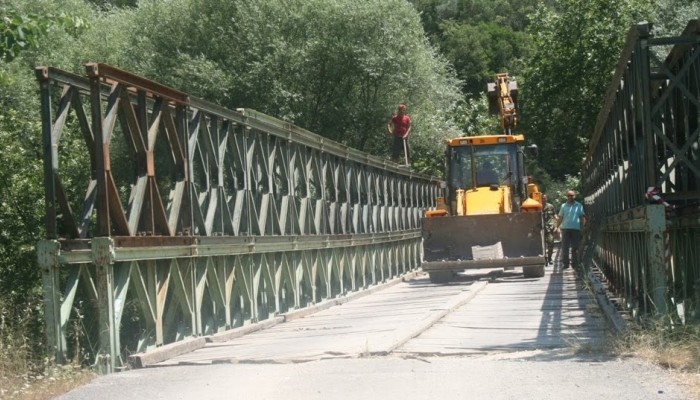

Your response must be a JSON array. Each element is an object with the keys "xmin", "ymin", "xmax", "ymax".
[{"xmin": 36, "ymin": 21, "xmax": 700, "ymax": 372}]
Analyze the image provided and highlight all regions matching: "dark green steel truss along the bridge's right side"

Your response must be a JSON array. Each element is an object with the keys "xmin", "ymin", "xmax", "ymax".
[{"xmin": 582, "ymin": 20, "xmax": 700, "ymax": 323}]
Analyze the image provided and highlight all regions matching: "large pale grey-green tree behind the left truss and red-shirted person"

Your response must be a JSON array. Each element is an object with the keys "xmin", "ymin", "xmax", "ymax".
[{"xmin": 136, "ymin": 0, "xmax": 460, "ymax": 164}]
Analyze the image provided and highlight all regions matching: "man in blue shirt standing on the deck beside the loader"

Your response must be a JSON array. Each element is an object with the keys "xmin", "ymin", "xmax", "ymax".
[{"xmin": 557, "ymin": 190, "xmax": 586, "ymax": 269}]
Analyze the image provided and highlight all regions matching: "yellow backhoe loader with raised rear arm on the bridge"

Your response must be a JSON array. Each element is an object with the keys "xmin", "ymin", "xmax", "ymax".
[{"xmin": 422, "ymin": 74, "xmax": 546, "ymax": 283}]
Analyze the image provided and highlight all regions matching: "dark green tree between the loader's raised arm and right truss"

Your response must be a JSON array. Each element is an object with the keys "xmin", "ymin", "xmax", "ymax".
[{"xmin": 520, "ymin": 0, "xmax": 648, "ymax": 179}]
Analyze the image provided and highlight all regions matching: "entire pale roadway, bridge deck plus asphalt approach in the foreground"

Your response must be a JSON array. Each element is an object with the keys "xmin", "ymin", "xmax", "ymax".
[{"xmin": 54, "ymin": 267, "xmax": 690, "ymax": 400}]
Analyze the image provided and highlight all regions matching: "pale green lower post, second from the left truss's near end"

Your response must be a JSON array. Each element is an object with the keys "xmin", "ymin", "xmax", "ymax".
[{"xmin": 92, "ymin": 237, "xmax": 120, "ymax": 374}]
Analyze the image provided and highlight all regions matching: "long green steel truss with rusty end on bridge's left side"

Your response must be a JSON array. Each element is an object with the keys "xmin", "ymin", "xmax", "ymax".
[{"xmin": 36, "ymin": 64, "xmax": 438, "ymax": 371}]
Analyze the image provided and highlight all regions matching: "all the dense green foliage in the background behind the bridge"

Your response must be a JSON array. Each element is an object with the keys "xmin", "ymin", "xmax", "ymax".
[{"xmin": 0, "ymin": 0, "xmax": 700, "ymax": 386}]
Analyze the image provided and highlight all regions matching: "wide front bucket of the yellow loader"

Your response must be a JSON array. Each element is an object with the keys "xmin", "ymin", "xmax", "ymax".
[{"xmin": 422, "ymin": 212, "xmax": 545, "ymax": 271}]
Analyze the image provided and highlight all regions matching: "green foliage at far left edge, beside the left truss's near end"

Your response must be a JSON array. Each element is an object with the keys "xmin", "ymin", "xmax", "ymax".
[{"xmin": 0, "ymin": 1, "xmax": 94, "ymax": 304}]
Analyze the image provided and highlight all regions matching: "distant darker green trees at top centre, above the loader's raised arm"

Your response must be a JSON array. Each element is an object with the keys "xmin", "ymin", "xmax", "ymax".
[{"xmin": 412, "ymin": 0, "xmax": 540, "ymax": 141}]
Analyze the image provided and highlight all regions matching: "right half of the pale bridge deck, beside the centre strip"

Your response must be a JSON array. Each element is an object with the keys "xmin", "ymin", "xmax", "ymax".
[{"xmin": 397, "ymin": 250, "xmax": 610, "ymax": 359}]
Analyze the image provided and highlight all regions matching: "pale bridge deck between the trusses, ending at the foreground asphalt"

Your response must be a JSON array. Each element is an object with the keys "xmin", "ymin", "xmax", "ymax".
[{"xmin": 155, "ymin": 260, "xmax": 607, "ymax": 366}]
